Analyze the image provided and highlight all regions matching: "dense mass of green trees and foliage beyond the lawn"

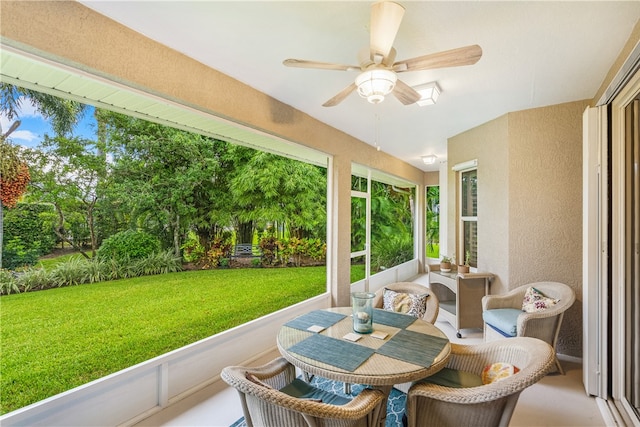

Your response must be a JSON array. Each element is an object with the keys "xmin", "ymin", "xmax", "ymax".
[{"xmin": 0, "ymin": 84, "xmax": 326, "ymax": 268}]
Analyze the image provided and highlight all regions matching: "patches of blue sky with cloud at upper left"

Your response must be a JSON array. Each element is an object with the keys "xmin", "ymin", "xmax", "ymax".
[{"xmin": 0, "ymin": 100, "xmax": 95, "ymax": 148}]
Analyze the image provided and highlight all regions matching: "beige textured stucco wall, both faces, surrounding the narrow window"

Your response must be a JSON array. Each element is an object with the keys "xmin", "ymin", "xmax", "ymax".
[{"xmin": 448, "ymin": 100, "xmax": 589, "ymax": 357}]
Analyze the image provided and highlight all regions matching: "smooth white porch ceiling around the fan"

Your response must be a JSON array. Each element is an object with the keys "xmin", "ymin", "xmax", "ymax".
[{"xmin": 81, "ymin": 0, "xmax": 640, "ymax": 170}]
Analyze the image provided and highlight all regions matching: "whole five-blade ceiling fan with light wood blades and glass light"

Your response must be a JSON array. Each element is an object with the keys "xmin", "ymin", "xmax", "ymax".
[{"xmin": 283, "ymin": 1, "xmax": 482, "ymax": 107}]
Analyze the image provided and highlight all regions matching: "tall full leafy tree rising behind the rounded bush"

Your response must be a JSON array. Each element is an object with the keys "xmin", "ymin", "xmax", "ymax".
[{"xmin": 99, "ymin": 110, "xmax": 228, "ymax": 255}]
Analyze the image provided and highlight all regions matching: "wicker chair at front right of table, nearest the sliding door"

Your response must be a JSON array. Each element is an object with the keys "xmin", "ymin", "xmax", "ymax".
[{"xmin": 406, "ymin": 337, "xmax": 554, "ymax": 427}]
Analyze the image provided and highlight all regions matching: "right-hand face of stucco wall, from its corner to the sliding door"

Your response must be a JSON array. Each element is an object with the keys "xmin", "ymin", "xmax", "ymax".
[{"xmin": 508, "ymin": 100, "xmax": 589, "ymax": 356}]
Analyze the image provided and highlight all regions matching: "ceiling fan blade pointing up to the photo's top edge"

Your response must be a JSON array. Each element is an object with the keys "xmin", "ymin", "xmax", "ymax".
[{"xmin": 369, "ymin": 1, "xmax": 404, "ymax": 62}]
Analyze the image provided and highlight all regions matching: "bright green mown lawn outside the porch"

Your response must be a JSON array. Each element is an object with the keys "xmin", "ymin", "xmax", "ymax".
[{"xmin": 0, "ymin": 267, "xmax": 326, "ymax": 413}]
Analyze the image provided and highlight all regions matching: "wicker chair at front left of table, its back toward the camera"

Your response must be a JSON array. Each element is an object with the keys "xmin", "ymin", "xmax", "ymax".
[{"xmin": 221, "ymin": 357, "xmax": 386, "ymax": 427}]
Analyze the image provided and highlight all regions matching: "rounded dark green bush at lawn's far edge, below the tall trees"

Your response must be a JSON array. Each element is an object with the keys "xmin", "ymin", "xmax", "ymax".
[{"xmin": 97, "ymin": 230, "xmax": 160, "ymax": 261}]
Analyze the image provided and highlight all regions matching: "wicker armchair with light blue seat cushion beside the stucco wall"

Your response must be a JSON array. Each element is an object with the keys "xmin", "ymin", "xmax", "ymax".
[{"xmin": 482, "ymin": 282, "xmax": 576, "ymax": 374}]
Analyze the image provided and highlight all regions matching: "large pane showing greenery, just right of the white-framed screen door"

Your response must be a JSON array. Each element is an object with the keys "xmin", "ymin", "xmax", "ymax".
[{"xmin": 370, "ymin": 181, "xmax": 415, "ymax": 274}]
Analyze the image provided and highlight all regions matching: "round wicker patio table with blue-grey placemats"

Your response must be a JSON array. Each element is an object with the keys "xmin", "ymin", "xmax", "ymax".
[{"xmin": 277, "ymin": 307, "xmax": 451, "ymax": 425}]
